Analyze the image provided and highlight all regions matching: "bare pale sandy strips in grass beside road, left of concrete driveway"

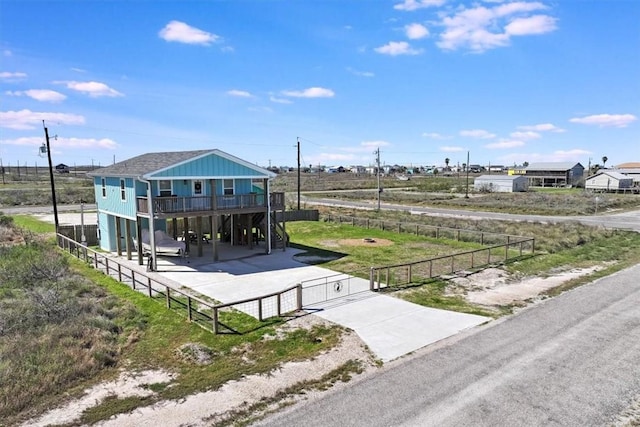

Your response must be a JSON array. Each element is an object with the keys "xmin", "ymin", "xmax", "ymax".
[{"xmin": 23, "ymin": 315, "xmax": 376, "ymax": 427}]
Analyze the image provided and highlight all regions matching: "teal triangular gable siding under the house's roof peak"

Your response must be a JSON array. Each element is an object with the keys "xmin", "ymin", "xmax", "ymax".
[{"xmin": 152, "ymin": 154, "xmax": 265, "ymax": 178}]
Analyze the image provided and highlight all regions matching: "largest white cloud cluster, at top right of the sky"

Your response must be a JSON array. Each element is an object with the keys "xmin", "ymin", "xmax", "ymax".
[{"xmin": 436, "ymin": 1, "xmax": 557, "ymax": 53}]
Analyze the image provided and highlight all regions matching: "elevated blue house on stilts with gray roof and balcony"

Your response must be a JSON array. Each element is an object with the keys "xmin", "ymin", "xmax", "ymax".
[{"xmin": 89, "ymin": 149, "xmax": 286, "ymax": 266}]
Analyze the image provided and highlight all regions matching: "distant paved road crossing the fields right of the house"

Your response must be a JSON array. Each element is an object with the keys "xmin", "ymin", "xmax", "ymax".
[{"xmin": 302, "ymin": 196, "xmax": 640, "ymax": 231}]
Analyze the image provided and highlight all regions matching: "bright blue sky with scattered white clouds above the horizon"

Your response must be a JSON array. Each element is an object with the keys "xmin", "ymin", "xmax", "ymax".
[{"xmin": 0, "ymin": 0, "xmax": 640, "ymax": 171}]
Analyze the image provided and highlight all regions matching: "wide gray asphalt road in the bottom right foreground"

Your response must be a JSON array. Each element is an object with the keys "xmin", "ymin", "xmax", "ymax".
[{"xmin": 257, "ymin": 266, "xmax": 640, "ymax": 427}]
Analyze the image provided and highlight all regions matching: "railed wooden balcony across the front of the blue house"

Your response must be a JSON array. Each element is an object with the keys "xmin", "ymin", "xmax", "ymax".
[{"xmin": 137, "ymin": 193, "xmax": 284, "ymax": 218}]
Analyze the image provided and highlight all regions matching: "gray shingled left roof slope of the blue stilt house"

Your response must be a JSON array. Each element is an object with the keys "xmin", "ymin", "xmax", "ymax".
[{"xmin": 88, "ymin": 150, "xmax": 215, "ymax": 177}]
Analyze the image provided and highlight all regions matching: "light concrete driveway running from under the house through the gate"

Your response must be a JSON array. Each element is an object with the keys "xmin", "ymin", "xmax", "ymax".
[{"xmin": 151, "ymin": 246, "xmax": 491, "ymax": 362}]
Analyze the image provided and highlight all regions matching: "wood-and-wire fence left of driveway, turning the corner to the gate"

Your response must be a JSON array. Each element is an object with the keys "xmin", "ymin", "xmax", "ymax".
[{"xmin": 57, "ymin": 234, "xmax": 302, "ymax": 334}]
